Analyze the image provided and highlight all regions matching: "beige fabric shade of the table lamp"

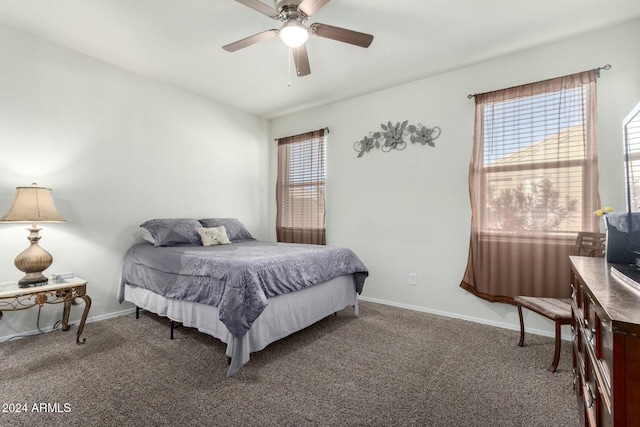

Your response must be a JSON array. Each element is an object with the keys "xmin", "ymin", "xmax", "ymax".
[{"xmin": 0, "ymin": 184, "xmax": 66, "ymax": 223}]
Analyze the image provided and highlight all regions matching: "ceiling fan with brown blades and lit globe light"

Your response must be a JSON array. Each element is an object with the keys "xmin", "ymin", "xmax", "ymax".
[{"xmin": 222, "ymin": 0, "xmax": 373, "ymax": 77}]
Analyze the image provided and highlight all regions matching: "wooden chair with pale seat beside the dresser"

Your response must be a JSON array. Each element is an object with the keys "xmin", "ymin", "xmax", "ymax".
[{"xmin": 513, "ymin": 232, "xmax": 606, "ymax": 372}]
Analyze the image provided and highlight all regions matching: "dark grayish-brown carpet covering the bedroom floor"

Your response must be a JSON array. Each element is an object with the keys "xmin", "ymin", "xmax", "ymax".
[{"xmin": 0, "ymin": 302, "xmax": 578, "ymax": 427}]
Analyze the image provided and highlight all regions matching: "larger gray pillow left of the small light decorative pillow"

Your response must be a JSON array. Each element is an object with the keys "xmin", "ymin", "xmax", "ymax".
[{"xmin": 140, "ymin": 218, "xmax": 202, "ymax": 246}]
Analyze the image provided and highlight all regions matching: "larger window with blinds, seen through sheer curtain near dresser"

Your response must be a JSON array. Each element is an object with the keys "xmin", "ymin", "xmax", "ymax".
[{"xmin": 479, "ymin": 86, "xmax": 595, "ymax": 236}]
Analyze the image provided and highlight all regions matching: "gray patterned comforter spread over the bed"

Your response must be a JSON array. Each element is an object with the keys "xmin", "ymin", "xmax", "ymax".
[{"xmin": 118, "ymin": 240, "xmax": 369, "ymax": 338}]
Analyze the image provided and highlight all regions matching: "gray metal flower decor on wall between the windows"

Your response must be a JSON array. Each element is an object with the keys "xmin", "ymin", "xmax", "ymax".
[{"xmin": 353, "ymin": 120, "xmax": 440, "ymax": 157}]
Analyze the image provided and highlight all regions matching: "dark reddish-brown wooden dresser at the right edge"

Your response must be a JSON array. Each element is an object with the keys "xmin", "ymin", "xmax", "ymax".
[{"xmin": 570, "ymin": 256, "xmax": 640, "ymax": 426}]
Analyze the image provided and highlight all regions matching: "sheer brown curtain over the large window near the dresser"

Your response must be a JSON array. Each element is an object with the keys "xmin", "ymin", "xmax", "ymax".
[{"xmin": 460, "ymin": 70, "xmax": 600, "ymax": 303}]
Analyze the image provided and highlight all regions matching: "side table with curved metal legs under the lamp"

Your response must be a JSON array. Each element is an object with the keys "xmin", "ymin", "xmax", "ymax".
[{"xmin": 0, "ymin": 277, "xmax": 91, "ymax": 344}]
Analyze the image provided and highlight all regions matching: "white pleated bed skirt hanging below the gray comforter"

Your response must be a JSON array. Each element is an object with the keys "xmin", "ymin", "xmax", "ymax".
[{"xmin": 124, "ymin": 274, "xmax": 358, "ymax": 377}]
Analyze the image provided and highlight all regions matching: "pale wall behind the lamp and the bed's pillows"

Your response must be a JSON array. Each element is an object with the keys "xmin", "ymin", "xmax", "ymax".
[{"xmin": 0, "ymin": 26, "xmax": 272, "ymax": 340}]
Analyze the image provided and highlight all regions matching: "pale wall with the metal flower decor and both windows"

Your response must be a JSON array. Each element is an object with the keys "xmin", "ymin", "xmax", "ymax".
[{"xmin": 271, "ymin": 21, "xmax": 640, "ymax": 334}]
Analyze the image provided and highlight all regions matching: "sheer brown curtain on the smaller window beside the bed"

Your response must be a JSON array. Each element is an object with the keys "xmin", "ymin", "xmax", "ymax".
[{"xmin": 276, "ymin": 129, "xmax": 326, "ymax": 245}]
